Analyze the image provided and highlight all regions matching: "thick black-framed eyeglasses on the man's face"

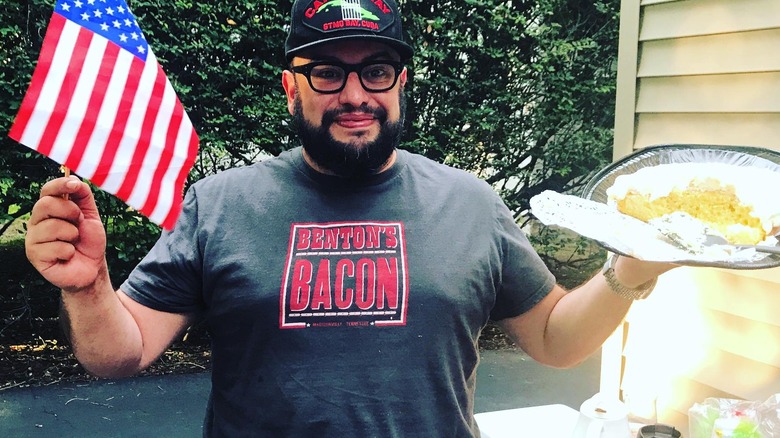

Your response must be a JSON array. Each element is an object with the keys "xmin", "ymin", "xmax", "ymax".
[{"xmin": 290, "ymin": 61, "xmax": 403, "ymax": 94}]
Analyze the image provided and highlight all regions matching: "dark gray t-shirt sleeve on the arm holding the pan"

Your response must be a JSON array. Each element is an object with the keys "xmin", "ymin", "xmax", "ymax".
[{"xmin": 490, "ymin": 197, "xmax": 556, "ymax": 321}]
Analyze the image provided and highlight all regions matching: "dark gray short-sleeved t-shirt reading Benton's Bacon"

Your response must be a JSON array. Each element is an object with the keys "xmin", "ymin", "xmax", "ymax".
[{"xmin": 121, "ymin": 148, "xmax": 555, "ymax": 438}]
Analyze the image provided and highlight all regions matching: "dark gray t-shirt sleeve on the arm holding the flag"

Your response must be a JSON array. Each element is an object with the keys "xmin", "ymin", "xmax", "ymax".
[{"xmin": 120, "ymin": 186, "xmax": 203, "ymax": 313}]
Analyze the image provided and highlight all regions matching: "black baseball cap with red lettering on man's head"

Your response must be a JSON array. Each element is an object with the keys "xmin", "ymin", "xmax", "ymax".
[{"xmin": 284, "ymin": 0, "xmax": 414, "ymax": 61}]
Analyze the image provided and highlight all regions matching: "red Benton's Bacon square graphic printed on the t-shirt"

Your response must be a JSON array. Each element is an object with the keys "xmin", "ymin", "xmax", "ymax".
[{"xmin": 279, "ymin": 222, "xmax": 409, "ymax": 328}]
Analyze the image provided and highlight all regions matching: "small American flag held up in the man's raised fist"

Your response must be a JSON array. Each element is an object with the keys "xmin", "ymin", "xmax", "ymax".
[{"xmin": 9, "ymin": 0, "xmax": 198, "ymax": 229}]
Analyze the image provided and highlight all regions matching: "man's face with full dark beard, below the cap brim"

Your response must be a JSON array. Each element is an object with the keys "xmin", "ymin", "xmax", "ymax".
[{"xmin": 282, "ymin": 41, "xmax": 406, "ymax": 177}]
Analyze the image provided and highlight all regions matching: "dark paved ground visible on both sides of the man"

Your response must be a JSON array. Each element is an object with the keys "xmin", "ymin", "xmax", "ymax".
[{"xmin": 0, "ymin": 351, "xmax": 600, "ymax": 438}]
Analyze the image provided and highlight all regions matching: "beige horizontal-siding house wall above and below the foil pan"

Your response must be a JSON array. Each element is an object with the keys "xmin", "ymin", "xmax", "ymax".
[{"xmin": 614, "ymin": 0, "xmax": 780, "ymax": 435}]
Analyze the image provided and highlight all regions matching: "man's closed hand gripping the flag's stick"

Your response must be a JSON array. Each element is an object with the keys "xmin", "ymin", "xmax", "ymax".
[{"xmin": 25, "ymin": 177, "xmax": 107, "ymax": 292}]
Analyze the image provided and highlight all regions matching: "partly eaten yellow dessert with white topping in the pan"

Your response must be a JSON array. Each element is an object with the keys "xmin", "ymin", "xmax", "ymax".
[{"xmin": 607, "ymin": 163, "xmax": 780, "ymax": 244}]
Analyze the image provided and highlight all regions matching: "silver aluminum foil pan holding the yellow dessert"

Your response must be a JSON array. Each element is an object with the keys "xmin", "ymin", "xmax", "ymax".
[{"xmin": 531, "ymin": 145, "xmax": 780, "ymax": 269}]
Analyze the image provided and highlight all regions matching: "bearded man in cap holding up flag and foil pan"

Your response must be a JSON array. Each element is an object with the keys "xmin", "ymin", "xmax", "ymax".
[{"xmin": 26, "ymin": 0, "xmax": 671, "ymax": 438}]
